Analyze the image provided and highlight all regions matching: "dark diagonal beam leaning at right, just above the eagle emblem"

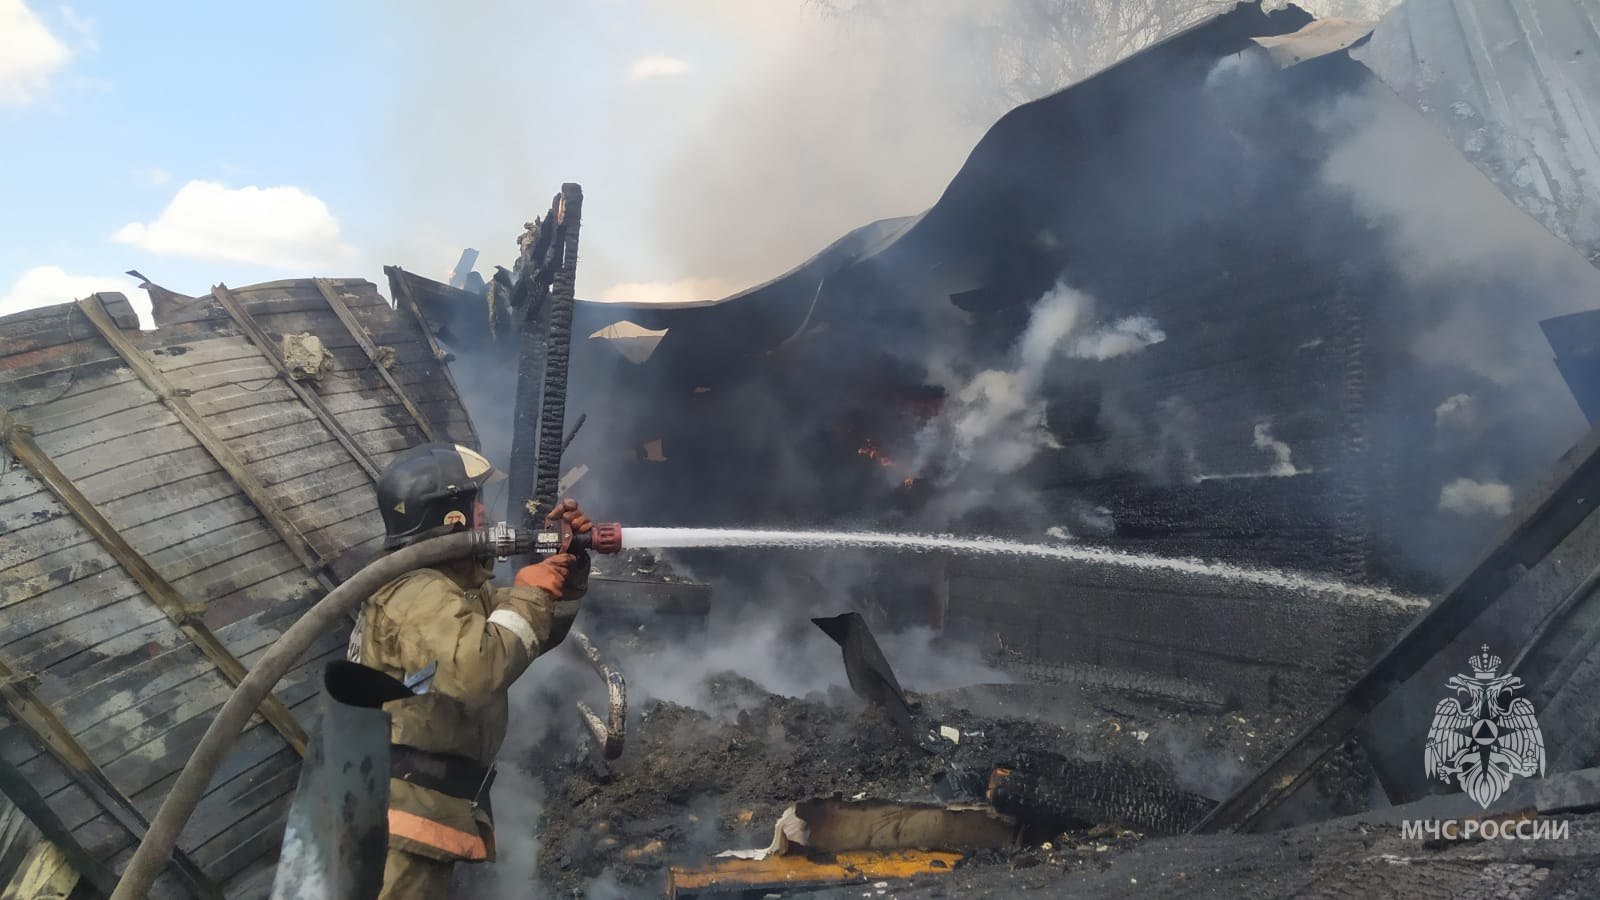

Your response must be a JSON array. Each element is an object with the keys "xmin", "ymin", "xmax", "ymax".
[{"xmin": 1195, "ymin": 416, "xmax": 1600, "ymax": 833}]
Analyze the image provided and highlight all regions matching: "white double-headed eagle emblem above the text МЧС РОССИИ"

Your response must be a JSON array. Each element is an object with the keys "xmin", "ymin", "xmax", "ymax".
[{"xmin": 1424, "ymin": 644, "xmax": 1544, "ymax": 809}]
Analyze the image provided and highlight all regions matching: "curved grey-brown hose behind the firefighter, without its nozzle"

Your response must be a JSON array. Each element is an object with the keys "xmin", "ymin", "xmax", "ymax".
[{"xmin": 112, "ymin": 532, "xmax": 488, "ymax": 900}]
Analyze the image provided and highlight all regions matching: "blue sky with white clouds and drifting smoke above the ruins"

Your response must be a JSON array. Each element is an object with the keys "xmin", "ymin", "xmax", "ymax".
[{"xmin": 0, "ymin": 0, "xmax": 981, "ymax": 321}]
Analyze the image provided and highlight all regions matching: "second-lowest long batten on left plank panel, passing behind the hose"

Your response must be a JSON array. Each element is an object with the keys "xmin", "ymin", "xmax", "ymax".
[{"xmin": 0, "ymin": 410, "xmax": 309, "ymax": 756}]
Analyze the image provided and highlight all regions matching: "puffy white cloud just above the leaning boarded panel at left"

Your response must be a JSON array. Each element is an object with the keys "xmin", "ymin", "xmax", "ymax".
[{"xmin": 114, "ymin": 181, "xmax": 360, "ymax": 271}]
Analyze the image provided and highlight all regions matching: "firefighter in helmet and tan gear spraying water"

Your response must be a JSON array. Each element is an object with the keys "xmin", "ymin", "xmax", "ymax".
[{"xmin": 349, "ymin": 444, "xmax": 594, "ymax": 900}]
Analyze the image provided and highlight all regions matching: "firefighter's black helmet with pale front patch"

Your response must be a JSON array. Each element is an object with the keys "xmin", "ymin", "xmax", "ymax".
[{"xmin": 378, "ymin": 444, "xmax": 499, "ymax": 549}]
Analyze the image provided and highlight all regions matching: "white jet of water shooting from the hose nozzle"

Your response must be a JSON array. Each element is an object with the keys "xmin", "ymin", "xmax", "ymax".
[{"xmin": 622, "ymin": 527, "xmax": 1427, "ymax": 609}]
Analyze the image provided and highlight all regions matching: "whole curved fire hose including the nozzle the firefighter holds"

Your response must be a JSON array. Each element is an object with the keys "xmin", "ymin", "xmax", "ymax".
[{"xmin": 112, "ymin": 524, "xmax": 622, "ymax": 900}]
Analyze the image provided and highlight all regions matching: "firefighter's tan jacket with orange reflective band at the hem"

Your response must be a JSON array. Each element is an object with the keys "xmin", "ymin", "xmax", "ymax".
[{"xmin": 349, "ymin": 562, "xmax": 587, "ymax": 860}]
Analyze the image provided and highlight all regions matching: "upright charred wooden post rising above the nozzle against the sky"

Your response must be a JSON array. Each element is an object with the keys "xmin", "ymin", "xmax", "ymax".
[{"xmin": 533, "ymin": 184, "xmax": 584, "ymax": 509}]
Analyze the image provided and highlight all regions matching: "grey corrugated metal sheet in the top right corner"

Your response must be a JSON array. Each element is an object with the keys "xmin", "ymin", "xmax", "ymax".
[{"xmin": 1352, "ymin": 0, "xmax": 1600, "ymax": 264}]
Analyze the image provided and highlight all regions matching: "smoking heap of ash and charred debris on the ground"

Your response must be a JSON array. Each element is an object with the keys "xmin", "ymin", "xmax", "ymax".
[{"xmin": 525, "ymin": 557, "xmax": 1298, "ymax": 897}]
